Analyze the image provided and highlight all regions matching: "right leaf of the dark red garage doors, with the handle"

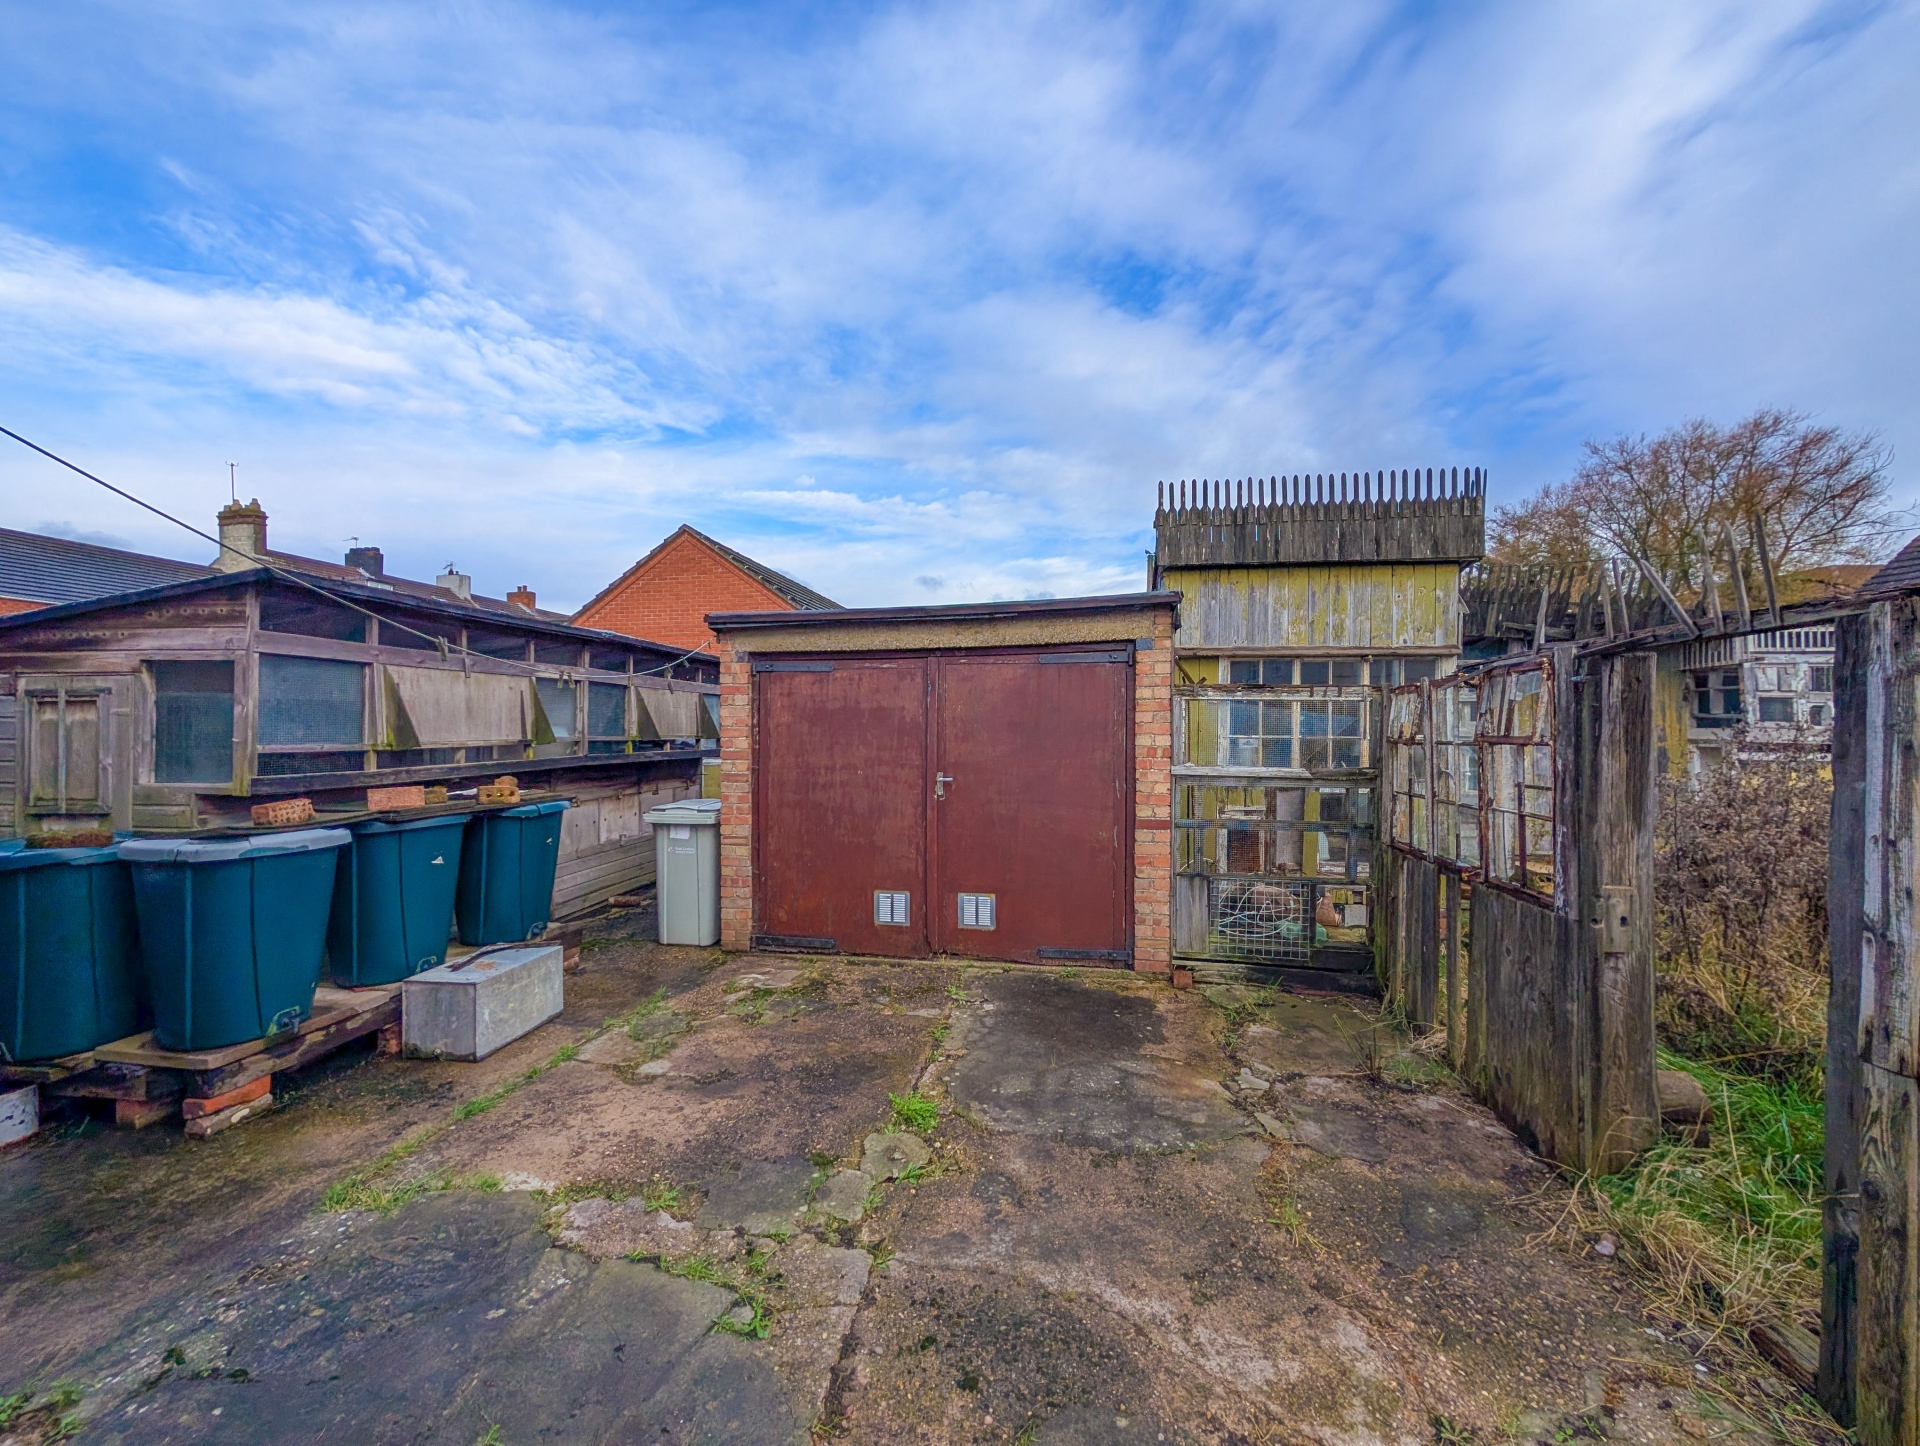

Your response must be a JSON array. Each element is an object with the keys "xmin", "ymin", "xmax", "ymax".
[{"xmin": 931, "ymin": 649, "xmax": 1133, "ymax": 964}]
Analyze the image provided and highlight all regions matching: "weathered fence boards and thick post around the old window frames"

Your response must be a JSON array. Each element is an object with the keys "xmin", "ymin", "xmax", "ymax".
[{"xmin": 1379, "ymin": 647, "xmax": 1659, "ymax": 1173}]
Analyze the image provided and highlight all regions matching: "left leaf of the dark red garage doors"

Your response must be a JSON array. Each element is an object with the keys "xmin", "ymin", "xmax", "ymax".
[{"xmin": 753, "ymin": 659, "xmax": 927, "ymax": 956}]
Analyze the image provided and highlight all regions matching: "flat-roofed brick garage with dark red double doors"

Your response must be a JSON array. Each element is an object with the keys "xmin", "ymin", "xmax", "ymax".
[{"xmin": 708, "ymin": 593, "xmax": 1177, "ymax": 970}]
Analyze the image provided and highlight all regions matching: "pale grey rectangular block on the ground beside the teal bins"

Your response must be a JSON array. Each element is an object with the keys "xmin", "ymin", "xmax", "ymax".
[{"xmin": 399, "ymin": 945, "xmax": 564, "ymax": 1060}]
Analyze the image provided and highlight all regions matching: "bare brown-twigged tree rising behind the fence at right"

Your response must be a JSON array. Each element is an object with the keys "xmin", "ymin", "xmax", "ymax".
[{"xmin": 1492, "ymin": 407, "xmax": 1891, "ymax": 595}]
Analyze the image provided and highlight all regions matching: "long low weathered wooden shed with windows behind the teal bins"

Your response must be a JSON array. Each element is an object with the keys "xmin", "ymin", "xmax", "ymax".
[{"xmin": 0, "ymin": 566, "xmax": 720, "ymax": 916}]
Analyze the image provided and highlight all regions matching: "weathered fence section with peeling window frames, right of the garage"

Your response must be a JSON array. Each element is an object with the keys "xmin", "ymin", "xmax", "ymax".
[{"xmin": 1377, "ymin": 645, "xmax": 1659, "ymax": 1173}]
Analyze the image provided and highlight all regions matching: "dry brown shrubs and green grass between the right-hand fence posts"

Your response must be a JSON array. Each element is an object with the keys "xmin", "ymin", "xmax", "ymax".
[{"xmin": 1569, "ymin": 745, "xmax": 1832, "ymax": 1335}]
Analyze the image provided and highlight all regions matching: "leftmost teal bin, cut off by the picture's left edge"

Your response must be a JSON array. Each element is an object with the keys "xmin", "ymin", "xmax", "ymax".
[{"xmin": 0, "ymin": 845, "xmax": 146, "ymax": 1060}]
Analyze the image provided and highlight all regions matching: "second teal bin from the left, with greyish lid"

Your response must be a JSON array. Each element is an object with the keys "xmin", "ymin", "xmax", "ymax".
[{"xmin": 119, "ymin": 828, "xmax": 353, "ymax": 1050}]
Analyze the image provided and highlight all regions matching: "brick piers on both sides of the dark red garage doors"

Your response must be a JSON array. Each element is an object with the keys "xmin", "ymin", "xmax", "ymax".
[{"xmin": 716, "ymin": 609, "xmax": 1173, "ymax": 974}]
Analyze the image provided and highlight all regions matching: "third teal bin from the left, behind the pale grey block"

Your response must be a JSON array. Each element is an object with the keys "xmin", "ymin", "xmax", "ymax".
[{"xmin": 326, "ymin": 814, "xmax": 468, "ymax": 989}]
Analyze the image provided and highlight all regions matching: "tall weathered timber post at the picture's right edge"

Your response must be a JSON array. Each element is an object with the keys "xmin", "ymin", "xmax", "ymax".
[{"xmin": 1818, "ymin": 595, "xmax": 1920, "ymax": 1446}]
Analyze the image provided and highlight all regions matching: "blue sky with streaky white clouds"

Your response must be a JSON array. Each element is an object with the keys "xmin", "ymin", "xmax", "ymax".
[{"xmin": 0, "ymin": 0, "xmax": 1920, "ymax": 609}]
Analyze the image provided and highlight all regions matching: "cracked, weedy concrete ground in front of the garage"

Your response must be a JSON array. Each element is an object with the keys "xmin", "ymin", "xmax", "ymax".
[{"xmin": 0, "ymin": 914, "xmax": 1797, "ymax": 1446}]
